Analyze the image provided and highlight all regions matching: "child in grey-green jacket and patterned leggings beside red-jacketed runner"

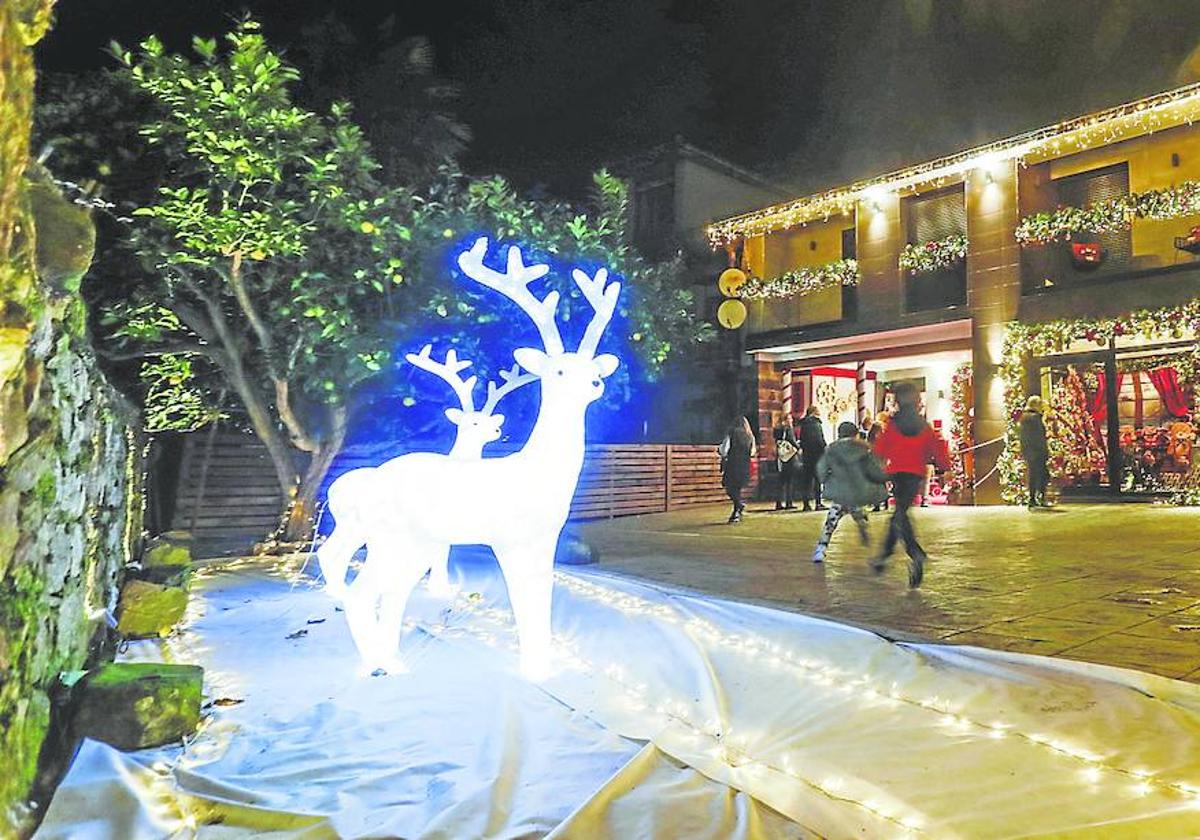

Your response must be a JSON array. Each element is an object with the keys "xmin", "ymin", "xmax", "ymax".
[{"xmin": 812, "ymin": 421, "xmax": 888, "ymax": 563}]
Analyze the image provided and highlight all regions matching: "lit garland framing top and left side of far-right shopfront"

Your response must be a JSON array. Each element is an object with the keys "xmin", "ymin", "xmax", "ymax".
[{"xmin": 997, "ymin": 298, "xmax": 1200, "ymax": 504}]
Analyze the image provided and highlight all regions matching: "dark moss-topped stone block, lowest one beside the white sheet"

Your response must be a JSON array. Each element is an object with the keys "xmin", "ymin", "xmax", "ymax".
[{"xmin": 74, "ymin": 662, "xmax": 204, "ymax": 750}]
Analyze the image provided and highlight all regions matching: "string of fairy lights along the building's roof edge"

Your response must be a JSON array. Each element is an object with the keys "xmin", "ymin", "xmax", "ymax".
[{"xmin": 707, "ymin": 83, "xmax": 1200, "ymax": 248}]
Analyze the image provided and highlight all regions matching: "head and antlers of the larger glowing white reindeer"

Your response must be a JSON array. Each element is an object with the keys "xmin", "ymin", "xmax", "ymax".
[{"xmin": 458, "ymin": 236, "xmax": 620, "ymax": 406}]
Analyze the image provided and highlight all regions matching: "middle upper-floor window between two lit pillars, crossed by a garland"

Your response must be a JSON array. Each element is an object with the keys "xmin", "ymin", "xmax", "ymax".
[{"xmin": 904, "ymin": 184, "xmax": 967, "ymax": 312}]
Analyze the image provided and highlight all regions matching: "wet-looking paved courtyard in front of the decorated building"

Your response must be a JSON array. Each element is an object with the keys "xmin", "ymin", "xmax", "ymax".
[{"xmin": 580, "ymin": 504, "xmax": 1200, "ymax": 683}]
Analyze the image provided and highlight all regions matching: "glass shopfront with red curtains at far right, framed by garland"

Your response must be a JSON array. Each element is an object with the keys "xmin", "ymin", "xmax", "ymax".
[{"xmin": 1028, "ymin": 341, "xmax": 1198, "ymax": 498}]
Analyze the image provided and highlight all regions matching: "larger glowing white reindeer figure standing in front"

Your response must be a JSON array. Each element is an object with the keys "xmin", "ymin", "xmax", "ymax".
[{"xmin": 344, "ymin": 232, "xmax": 620, "ymax": 678}]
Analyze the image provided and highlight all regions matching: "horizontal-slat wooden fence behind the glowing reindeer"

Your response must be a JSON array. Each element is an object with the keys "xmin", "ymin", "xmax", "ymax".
[{"xmin": 172, "ymin": 430, "xmax": 726, "ymax": 539}]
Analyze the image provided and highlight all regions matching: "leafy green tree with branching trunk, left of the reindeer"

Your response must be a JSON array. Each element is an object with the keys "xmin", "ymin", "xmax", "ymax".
[{"xmin": 106, "ymin": 22, "xmax": 409, "ymax": 536}]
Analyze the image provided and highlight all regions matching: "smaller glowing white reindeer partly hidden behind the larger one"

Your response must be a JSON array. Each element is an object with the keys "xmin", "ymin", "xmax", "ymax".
[{"xmin": 317, "ymin": 344, "xmax": 536, "ymax": 598}]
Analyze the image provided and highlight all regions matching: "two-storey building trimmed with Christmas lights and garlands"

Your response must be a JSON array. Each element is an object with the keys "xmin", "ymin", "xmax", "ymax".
[{"xmin": 707, "ymin": 84, "xmax": 1200, "ymax": 503}]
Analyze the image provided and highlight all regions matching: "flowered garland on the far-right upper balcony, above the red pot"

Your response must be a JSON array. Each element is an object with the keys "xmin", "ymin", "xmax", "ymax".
[{"xmin": 1015, "ymin": 181, "xmax": 1200, "ymax": 246}]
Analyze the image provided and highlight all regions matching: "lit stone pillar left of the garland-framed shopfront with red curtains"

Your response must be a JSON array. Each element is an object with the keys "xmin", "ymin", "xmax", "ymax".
[{"xmin": 966, "ymin": 161, "xmax": 1021, "ymax": 504}]
